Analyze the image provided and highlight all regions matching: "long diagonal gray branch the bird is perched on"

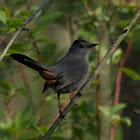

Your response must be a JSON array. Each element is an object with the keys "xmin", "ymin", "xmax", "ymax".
[{"xmin": 42, "ymin": 9, "xmax": 140, "ymax": 140}]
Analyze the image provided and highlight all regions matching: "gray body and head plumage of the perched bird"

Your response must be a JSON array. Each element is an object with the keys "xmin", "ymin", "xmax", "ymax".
[{"xmin": 51, "ymin": 40, "xmax": 90, "ymax": 93}]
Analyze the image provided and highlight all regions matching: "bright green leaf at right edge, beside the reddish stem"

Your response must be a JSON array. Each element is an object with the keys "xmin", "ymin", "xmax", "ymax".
[{"xmin": 119, "ymin": 67, "xmax": 140, "ymax": 80}]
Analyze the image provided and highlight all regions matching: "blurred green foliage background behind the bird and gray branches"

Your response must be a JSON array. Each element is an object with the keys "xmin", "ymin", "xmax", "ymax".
[{"xmin": 0, "ymin": 0, "xmax": 140, "ymax": 140}]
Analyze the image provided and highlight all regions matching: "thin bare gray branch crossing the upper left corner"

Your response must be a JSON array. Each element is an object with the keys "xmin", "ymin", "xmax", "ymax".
[{"xmin": 0, "ymin": 0, "xmax": 49, "ymax": 62}]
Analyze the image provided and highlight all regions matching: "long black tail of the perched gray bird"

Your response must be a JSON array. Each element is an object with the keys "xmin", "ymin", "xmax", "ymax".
[{"xmin": 10, "ymin": 54, "xmax": 49, "ymax": 72}]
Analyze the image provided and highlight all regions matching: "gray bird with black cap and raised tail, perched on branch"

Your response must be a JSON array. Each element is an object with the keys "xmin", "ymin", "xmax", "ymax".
[{"xmin": 10, "ymin": 39, "xmax": 98, "ymax": 113}]
